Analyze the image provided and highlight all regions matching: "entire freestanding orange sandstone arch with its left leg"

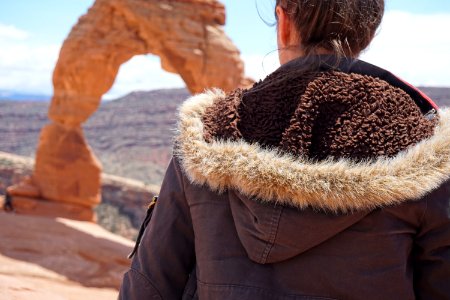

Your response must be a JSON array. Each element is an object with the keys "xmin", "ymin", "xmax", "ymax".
[{"xmin": 8, "ymin": 0, "xmax": 249, "ymax": 220}]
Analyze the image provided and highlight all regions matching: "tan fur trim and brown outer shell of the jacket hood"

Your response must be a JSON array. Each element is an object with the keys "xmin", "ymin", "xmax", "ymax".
[{"xmin": 175, "ymin": 57, "xmax": 450, "ymax": 263}]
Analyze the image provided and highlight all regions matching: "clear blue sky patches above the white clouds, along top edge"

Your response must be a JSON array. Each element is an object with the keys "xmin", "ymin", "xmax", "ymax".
[{"xmin": 0, "ymin": 0, "xmax": 450, "ymax": 53}]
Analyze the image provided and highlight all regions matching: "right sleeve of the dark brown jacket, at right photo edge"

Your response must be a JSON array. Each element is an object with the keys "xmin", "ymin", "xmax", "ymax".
[{"xmin": 414, "ymin": 182, "xmax": 450, "ymax": 300}]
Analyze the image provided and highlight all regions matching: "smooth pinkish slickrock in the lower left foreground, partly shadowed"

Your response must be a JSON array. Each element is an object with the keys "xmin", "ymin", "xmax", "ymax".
[{"xmin": 0, "ymin": 212, "xmax": 133, "ymax": 300}]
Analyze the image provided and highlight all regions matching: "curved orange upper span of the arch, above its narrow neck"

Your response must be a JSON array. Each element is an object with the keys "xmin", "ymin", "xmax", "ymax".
[{"xmin": 49, "ymin": 0, "xmax": 245, "ymax": 126}]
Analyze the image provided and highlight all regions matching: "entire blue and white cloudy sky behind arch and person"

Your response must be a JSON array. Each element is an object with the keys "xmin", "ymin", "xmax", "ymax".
[{"xmin": 0, "ymin": 0, "xmax": 450, "ymax": 97}]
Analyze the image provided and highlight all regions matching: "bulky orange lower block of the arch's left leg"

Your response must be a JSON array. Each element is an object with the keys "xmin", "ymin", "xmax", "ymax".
[{"xmin": 33, "ymin": 123, "xmax": 101, "ymax": 207}]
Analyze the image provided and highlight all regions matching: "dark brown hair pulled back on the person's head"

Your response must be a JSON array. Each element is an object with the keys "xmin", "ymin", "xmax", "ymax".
[{"xmin": 276, "ymin": 0, "xmax": 384, "ymax": 57}]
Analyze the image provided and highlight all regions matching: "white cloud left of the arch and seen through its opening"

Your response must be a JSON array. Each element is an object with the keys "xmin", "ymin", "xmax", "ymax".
[{"xmin": 0, "ymin": 23, "xmax": 185, "ymax": 99}]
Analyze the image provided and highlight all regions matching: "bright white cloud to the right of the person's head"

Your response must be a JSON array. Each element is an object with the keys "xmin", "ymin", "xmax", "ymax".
[{"xmin": 361, "ymin": 11, "xmax": 450, "ymax": 86}]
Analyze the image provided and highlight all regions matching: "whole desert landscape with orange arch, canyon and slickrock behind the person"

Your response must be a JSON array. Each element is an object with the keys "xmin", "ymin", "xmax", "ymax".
[{"xmin": 0, "ymin": 0, "xmax": 450, "ymax": 300}]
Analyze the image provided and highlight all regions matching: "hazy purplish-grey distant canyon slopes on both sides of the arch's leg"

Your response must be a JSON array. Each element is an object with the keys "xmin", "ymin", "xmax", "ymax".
[{"xmin": 0, "ymin": 89, "xmax": 189, "ymax": 185}]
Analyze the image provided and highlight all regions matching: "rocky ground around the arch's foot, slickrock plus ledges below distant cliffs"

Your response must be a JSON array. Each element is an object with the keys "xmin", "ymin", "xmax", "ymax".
[{"xmin": 0, "ymin": 152, "xmax": 158, "ymax": 300}]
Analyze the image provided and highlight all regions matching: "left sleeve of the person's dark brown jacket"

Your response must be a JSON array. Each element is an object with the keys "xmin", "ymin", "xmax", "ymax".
[{"xmin": 119, "ymin": 159, "xmax": 195, "ymax": 300}]
